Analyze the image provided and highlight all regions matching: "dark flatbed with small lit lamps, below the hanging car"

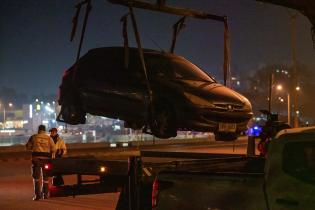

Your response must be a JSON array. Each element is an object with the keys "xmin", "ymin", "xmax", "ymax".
[{"xmin": 44, "ymin": 151, "xmax": 264, "ymax": 209}]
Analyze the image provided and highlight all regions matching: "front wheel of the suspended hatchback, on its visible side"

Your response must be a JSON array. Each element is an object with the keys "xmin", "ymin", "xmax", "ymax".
[{"xmin": 150, "ymin": 103, "xmax": 177, "ymax": 139}]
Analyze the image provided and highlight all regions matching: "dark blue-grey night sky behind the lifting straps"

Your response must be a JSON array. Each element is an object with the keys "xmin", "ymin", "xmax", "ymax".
[{"xmin": 0, "ymin": 0, "xmax": 315, "ymax": 96}]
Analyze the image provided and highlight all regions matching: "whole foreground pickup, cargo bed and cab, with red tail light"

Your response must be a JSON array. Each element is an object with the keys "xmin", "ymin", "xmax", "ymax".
[{"xmin": 152, "ymin": 127, "xmax": 315, "ymax": 210}]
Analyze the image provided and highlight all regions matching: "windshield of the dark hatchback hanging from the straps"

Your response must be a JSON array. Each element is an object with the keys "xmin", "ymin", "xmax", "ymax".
[{"xmin": 171, "ymin": 58, "xmax": 215, "ymax": 83}]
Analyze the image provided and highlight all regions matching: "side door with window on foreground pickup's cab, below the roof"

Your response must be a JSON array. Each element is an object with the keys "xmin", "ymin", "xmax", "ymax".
[{"xmin": 266, "ymin": 137, "xmax": 315, "ymax": 210}]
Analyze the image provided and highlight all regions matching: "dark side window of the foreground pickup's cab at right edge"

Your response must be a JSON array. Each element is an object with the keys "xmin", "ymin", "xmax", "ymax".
[{"xmin": 282, "ymin": 142, "xmax": 315, "ymax": 185}]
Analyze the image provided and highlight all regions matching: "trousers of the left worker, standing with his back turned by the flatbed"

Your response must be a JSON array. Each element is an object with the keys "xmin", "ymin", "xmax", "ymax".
[{"xmin": 32, "ymin": 158, "xmax": 49, "ymax": 197}]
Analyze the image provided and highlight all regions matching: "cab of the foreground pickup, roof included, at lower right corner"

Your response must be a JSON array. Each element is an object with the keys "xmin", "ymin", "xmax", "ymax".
[{"xmin": 265, "ymin": 127, "xmax": 315, "ymax": 210}]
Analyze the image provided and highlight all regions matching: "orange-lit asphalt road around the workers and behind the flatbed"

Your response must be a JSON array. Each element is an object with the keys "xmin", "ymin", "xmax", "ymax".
[{"xmin": 0, "ymin": 141, "xmax": 256, "ymax": 210}]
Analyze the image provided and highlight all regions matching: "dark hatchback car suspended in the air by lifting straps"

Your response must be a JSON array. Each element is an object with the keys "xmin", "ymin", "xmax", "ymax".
[{"xmin": 58, "ymin": 47, "xmax": 253, "ymax": 140}]
